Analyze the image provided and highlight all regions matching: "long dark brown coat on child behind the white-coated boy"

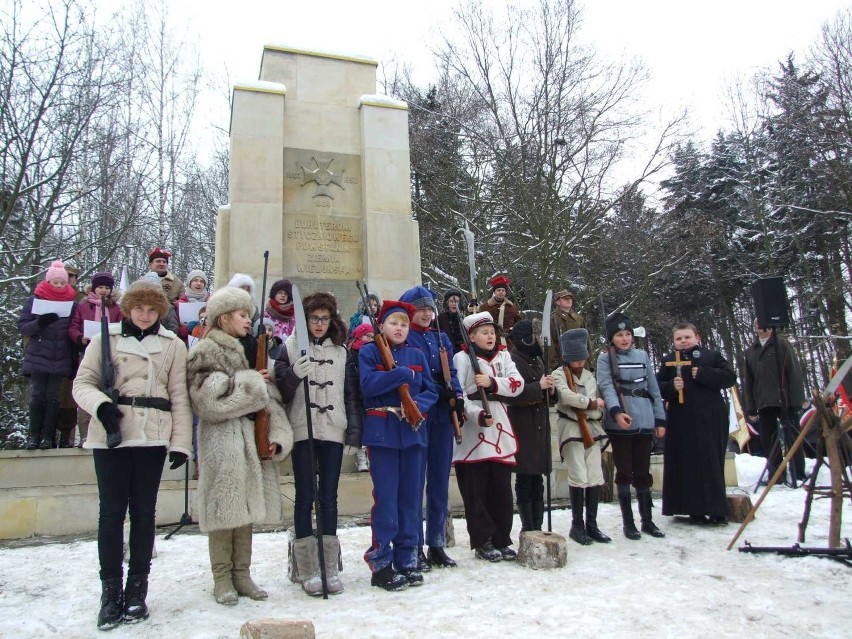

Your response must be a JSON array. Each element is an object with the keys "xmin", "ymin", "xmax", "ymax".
[{"xmin": 503, "ymin": 348, "xmax": 548, "ymax": 475}]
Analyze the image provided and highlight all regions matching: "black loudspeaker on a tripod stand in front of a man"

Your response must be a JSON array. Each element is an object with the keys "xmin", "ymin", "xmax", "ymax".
[{"xmin": 751, "ymin": 277, "xmax": 804, "ymax": 492}]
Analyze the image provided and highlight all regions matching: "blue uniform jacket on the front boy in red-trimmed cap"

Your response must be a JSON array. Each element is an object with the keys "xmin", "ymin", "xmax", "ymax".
[{"xmin": 358, "ymin": 344, "xmax": 438, "ymax": 449}]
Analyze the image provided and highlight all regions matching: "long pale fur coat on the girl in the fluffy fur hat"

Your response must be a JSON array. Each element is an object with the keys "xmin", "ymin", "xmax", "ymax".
[{"xmin": 187, "ymin": 329, "xmax": 293, "ymax": 532}]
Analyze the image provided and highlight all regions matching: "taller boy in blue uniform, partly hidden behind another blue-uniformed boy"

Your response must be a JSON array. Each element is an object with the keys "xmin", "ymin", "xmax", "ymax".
[{"xmin": 399, "ymin": 286, "xmax": 464, "ymax": 571}]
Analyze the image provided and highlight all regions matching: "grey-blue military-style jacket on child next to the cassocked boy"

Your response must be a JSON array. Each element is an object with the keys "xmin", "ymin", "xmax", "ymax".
[{"xmin": 596, "ymin": 348, "xmax": 666, "ymax": 434}]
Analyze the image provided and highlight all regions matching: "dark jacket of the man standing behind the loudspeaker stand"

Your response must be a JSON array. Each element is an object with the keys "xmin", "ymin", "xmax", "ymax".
[{"xmin": 745, "ymin": 335, "xmax": 805, "ymax": 415}]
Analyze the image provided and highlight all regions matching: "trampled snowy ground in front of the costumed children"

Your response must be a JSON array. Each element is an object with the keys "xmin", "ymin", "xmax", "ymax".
[{"xmin": 0, "ymin": 455, "xmax": 852, "ymax": 639}]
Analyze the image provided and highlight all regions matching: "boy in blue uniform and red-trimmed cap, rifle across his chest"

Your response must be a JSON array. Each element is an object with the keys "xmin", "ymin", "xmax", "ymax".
[{"xmin": 358, "ymin": 301, "xmax": 438, "ymax": 590}]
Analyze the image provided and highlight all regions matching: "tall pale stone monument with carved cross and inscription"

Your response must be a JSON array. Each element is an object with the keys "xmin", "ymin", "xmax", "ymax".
[{"xmin": 215, "ymin": 45, "xmax": 420, "ymax": 319}]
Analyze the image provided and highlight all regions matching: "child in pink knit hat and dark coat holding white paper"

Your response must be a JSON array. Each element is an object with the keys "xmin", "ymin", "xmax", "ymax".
[{"xmin": 18, "ymin": 261, "xmax": 77, "ymax": 450}]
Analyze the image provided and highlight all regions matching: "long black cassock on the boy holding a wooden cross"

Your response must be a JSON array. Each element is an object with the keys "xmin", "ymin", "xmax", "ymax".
[{"xmin": 657, "ymin": 346, "xmax": 737, "ymax": 517}]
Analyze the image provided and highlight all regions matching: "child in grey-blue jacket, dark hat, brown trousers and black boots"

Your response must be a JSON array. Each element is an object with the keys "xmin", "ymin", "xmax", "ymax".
[{"xmin": 597, "ymin": 312, "xmax": 666, "ymax": 540}]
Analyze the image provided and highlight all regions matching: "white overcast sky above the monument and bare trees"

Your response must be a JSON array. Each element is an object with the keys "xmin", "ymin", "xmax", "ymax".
[{"xmin": 97, "ymin": 0, "xmax": 852, "ymax": 146}]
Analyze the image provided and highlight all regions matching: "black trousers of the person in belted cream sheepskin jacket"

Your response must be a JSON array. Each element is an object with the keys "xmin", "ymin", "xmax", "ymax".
[{"xmin": 93, "ymin": 446, "xmax": 166, "ymax": 579}]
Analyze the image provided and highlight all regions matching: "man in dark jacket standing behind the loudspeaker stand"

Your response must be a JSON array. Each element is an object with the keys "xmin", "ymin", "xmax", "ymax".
[{"xmin": 745, "ymin": 320, "xmax": 808, "ymax": 479}]
